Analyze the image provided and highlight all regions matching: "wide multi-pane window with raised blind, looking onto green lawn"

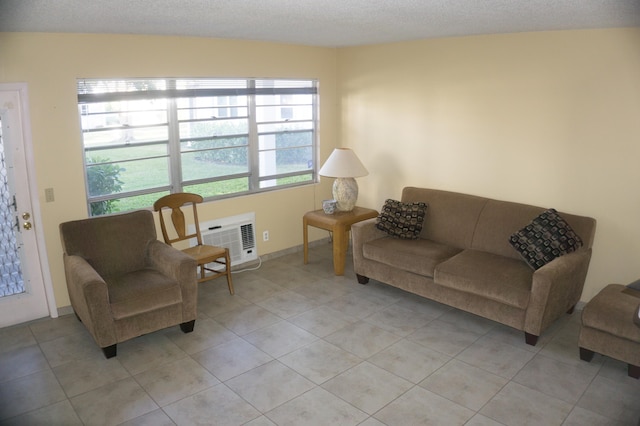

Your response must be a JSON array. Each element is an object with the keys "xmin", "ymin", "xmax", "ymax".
[{"xmin": 78, "ymin": 79, "xmax": 318, "ymax": 216}]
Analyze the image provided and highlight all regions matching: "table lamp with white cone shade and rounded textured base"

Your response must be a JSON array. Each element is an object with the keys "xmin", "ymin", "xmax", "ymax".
[{"xmin": 318, "ymin": 148, "xmax": 369, "ymax": 212}]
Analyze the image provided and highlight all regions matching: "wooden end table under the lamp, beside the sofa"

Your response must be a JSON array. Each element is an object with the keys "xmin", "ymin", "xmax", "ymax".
[{"xmin": 302, "ymin": 207, "xmax": 378, "ymax": 275}]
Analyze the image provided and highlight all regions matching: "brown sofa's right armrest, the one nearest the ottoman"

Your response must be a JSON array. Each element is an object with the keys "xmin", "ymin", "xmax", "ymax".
[{"xmin": 524, "ymin": 248, "xmax": 592, "ymax": 336}]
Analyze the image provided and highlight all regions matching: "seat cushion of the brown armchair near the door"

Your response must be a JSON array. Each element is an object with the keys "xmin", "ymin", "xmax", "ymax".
[{"xmin": 107, "ymin": 268, "xmax": 182, "ymax": 320}]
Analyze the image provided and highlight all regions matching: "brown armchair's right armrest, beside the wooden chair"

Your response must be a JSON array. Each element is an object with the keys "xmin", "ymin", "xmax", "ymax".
[{"xmin": 147, "ymin": 240, "xmax": 198, "ymax": 322}]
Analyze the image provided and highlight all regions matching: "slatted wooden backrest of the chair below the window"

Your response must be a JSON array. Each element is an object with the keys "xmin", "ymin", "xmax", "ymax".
[{"xmin": 153, "ymin": 192, "xmax": 202, "ymax": 245}]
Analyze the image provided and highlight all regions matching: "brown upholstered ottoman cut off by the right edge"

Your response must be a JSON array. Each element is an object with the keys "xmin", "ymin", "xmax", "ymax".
[{"xmin": 578, "ymin": 284, "xmax": 640, "ymax": 379}]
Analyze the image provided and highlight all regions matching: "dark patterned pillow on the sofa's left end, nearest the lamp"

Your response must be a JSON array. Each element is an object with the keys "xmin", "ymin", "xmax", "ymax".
[{"xmin": 376, "ymin": 200, "xmax": 427, "ymax": 240}]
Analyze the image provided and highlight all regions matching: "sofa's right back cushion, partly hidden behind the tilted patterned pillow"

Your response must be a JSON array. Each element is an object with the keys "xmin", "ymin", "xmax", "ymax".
[{"xmin": 471, "ymin": 200, "xmax": 595, "ymax": 259}]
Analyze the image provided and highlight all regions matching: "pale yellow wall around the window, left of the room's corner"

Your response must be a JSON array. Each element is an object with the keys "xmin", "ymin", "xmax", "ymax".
[{"xmin": 0, "ymin": 33, "xmax": 338, "ymax": 307}]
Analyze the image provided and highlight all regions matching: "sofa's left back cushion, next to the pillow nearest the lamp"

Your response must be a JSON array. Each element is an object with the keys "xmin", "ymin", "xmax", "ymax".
[{"xmin": 402, "ymin": 187, "xmax": 488, "ymax": 250}]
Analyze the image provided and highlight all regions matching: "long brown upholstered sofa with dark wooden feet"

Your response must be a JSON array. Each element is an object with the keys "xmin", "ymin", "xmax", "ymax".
[{"xmin": 351, "ymin": 187, "xmax": 596, "ymax": 346}]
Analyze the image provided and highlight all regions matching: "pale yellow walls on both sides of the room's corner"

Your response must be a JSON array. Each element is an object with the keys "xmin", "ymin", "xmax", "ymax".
[{"xmin": 0, "ymin": 29, "xmax": 640, "ymax": 307}]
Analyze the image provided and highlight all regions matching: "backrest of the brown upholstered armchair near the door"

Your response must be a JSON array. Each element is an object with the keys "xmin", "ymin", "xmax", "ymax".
[{"xmin": 59, "ymin": 210, "xmax": 157, "ymax": 277}]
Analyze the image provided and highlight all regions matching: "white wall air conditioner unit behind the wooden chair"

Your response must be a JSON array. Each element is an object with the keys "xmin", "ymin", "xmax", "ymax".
[{"xmin": 190, "ymin": 212, "xmax": 258, "ymax": 269}]
